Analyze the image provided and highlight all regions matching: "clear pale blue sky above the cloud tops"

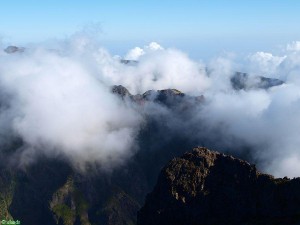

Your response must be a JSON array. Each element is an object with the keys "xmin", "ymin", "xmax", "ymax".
[{"xmin": 0, "ymin": 0, "xmax": 300, "ymax": 57}]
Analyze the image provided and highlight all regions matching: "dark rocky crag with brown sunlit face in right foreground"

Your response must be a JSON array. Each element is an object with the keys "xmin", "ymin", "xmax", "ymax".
[{"xmin": 138, "ymin": 148, "xmax": 300, "ymax": 225}]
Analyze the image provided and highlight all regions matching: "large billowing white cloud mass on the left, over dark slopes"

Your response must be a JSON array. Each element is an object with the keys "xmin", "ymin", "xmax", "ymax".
[{"xmin": 0, "ymin": 43, "xmax": 142, "ymax": 169}]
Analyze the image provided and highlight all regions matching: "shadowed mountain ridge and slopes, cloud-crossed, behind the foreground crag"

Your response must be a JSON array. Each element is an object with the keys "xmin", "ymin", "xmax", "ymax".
[{"xmin": 0, "ymin": 86, "xmax": 202, "ymax": 225}]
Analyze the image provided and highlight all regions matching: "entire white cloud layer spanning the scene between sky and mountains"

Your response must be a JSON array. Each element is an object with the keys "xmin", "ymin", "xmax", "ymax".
[{"xmin": 0, "ymin": 37, "xmax": 300, "ymax": 176}]
